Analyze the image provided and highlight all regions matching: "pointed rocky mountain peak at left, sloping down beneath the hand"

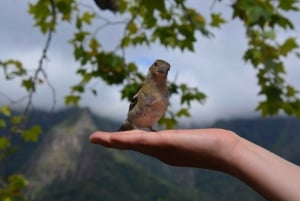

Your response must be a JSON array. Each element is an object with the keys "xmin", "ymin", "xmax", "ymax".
[{"xmin": 24, "ymin": 109, "xmax": 195, "ymax": 201}]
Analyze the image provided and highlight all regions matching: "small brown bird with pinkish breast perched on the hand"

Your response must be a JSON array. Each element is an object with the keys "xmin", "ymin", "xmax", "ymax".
[{"xmin": 118, "ymin": 59, "xmax": 170, "ymax": 131}]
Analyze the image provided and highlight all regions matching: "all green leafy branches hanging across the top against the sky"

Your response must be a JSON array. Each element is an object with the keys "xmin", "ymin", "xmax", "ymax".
[{"xmin": 0, "ymin": 0, "xmax": 300, "ymax": 128}]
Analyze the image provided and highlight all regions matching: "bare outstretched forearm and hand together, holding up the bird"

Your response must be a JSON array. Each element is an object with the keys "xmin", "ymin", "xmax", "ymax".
[{"xmin": 90, "ymin": 129, "xmax": 300, "ymax": 201}]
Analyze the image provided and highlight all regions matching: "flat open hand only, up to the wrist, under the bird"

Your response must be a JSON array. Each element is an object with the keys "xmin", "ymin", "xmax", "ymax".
[{"xmin": 90, "ymin": 129, "xmax": 239, "ymax": 171}]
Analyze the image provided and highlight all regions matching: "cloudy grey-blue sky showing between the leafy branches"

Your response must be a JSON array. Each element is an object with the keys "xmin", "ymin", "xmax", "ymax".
[{"xmin": 0, "ymin": 0, "xmax": 300, "ymax": 125}]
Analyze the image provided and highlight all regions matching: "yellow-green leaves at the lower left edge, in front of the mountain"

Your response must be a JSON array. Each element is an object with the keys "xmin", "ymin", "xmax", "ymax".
[{"xmin": 0, "ymin": 105, "xmax": 41, "ymax": 201}]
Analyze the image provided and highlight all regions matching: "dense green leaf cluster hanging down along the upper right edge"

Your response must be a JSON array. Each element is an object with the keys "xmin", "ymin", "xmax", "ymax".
[{"xmin": 232, "ymin": 0, "xmax": 300, "ymax": 117}]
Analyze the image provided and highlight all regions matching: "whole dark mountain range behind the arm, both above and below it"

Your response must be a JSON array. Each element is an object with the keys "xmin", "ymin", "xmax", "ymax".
[{"xmin": 2, "ymin": 109, "xmax": 300, "ymax": 201}]
